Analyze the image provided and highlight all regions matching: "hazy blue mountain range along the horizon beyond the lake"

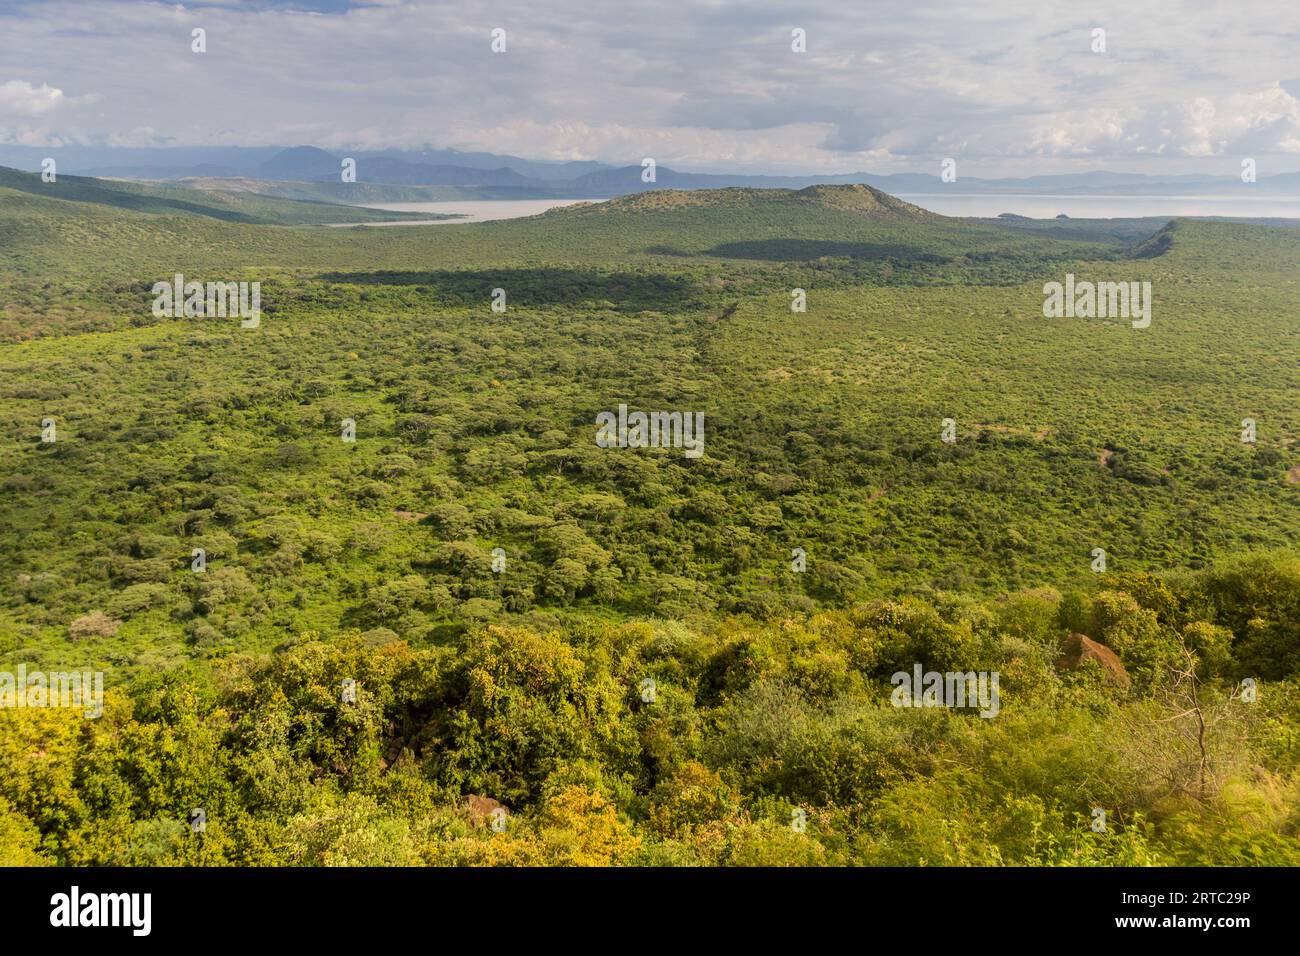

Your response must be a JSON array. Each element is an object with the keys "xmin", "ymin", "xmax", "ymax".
[{"xmin": 0, "ymin": 146, "xmax": 1300, "ymax": 202}]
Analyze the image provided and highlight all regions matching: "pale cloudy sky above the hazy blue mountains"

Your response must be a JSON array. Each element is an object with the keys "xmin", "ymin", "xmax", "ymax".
[{"xmin": 0, "ymin": 0, "xmax": 1300, "ymax": 177}]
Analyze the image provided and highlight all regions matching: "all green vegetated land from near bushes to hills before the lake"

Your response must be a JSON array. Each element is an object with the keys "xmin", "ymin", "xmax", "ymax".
[{"xmin": 0, "ymin": 174, "xmax": 1300, "ymax": 865}]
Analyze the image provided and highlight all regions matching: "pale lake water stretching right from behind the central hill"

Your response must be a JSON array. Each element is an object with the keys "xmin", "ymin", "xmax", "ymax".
[{"xmin": 898, "ymin": 193, "xmax": 1300, "ymax": 219}]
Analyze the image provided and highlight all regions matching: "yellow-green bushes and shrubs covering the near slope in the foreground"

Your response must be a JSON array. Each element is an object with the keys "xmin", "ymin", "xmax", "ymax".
[{"xmin": 0, "ymin": 555, "xmax": 1300, "ymax": 865}]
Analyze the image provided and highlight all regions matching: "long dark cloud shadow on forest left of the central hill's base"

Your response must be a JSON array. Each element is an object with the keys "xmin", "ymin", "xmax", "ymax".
[{"xmin": 317, "ymin": 267, "xmax": 701, "ymax": 312}]
